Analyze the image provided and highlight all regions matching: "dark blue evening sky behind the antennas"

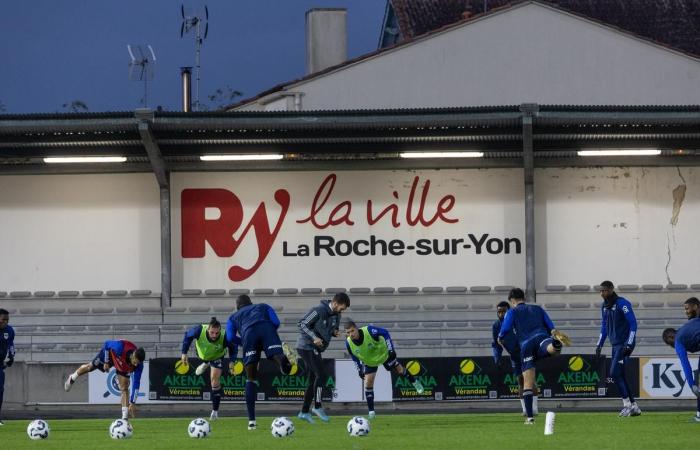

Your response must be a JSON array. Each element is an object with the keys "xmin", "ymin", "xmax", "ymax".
[{"xmin": 0, "ymin": 0, "xmax": 386, "ymax": 114}]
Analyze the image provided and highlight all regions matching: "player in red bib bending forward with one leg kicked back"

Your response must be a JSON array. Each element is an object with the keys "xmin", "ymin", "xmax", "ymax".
[{"xmin": 63, "ymin": 340, "xmax": 146, "ymax": 420}]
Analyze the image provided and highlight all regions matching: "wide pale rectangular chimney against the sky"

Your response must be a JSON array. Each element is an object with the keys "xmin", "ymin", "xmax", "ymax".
[{"xmin": 306, "ymin": 8, "xmax": 348, "ymax": 75}]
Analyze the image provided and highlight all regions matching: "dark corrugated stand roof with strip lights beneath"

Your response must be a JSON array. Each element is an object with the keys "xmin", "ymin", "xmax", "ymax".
[{"xmin": 0, "ymin": 104, "xmax": 700, "ymax": 174}]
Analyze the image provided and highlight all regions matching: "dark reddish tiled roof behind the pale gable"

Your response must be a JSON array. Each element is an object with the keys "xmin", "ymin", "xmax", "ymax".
[{"xmin": 390, "ymin": 0, "xmax": 700, "ymax": 56}]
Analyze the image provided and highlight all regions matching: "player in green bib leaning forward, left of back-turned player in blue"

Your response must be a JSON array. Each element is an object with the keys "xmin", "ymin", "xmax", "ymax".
[{"xmin": 180, "ymin": 317, "xmax": 238, "ymax": 420}]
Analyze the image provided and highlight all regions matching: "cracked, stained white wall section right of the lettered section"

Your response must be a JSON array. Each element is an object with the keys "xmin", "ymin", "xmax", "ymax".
[{"xmin": 535, "ymin": 167, "xmax": 700, "ymax": 288}]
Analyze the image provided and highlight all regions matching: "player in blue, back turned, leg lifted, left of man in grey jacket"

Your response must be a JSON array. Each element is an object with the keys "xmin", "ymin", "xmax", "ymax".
[{"xmin": 226, "ymin": 294, "xmax": 298, "ymax": 430}]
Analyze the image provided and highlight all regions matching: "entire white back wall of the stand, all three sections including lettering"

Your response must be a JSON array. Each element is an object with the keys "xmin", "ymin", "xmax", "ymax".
[{"xmin": 0, "ymin": 167, "xmax": 700, "ymax": 293}]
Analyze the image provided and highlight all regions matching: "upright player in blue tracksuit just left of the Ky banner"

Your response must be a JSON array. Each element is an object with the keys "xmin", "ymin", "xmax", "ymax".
[{"xmin": 595, "ymin": 280, "xmax": 642, "ymax": 417}]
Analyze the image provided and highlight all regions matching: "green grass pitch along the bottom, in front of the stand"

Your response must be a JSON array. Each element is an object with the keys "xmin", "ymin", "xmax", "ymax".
[{"xmin": 0, "ymin": 411, "xmax": 700, "ymax": 450}]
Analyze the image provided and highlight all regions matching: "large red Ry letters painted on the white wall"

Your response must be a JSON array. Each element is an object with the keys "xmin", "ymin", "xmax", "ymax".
[{"xmin": 181, "ymin": 189, "xmax": 290, "ymax": 281}]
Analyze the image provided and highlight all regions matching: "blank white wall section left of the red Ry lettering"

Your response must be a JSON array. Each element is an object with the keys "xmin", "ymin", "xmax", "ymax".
[{"xmin": 0, "ymin": 173, "xmax": 160, "ymax": 292}]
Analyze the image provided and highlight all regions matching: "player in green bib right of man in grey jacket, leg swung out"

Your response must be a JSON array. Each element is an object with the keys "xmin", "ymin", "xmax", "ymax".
[{"xmin": 345, "ymin": 319, "xmax": 423, "ymax": 419}]
